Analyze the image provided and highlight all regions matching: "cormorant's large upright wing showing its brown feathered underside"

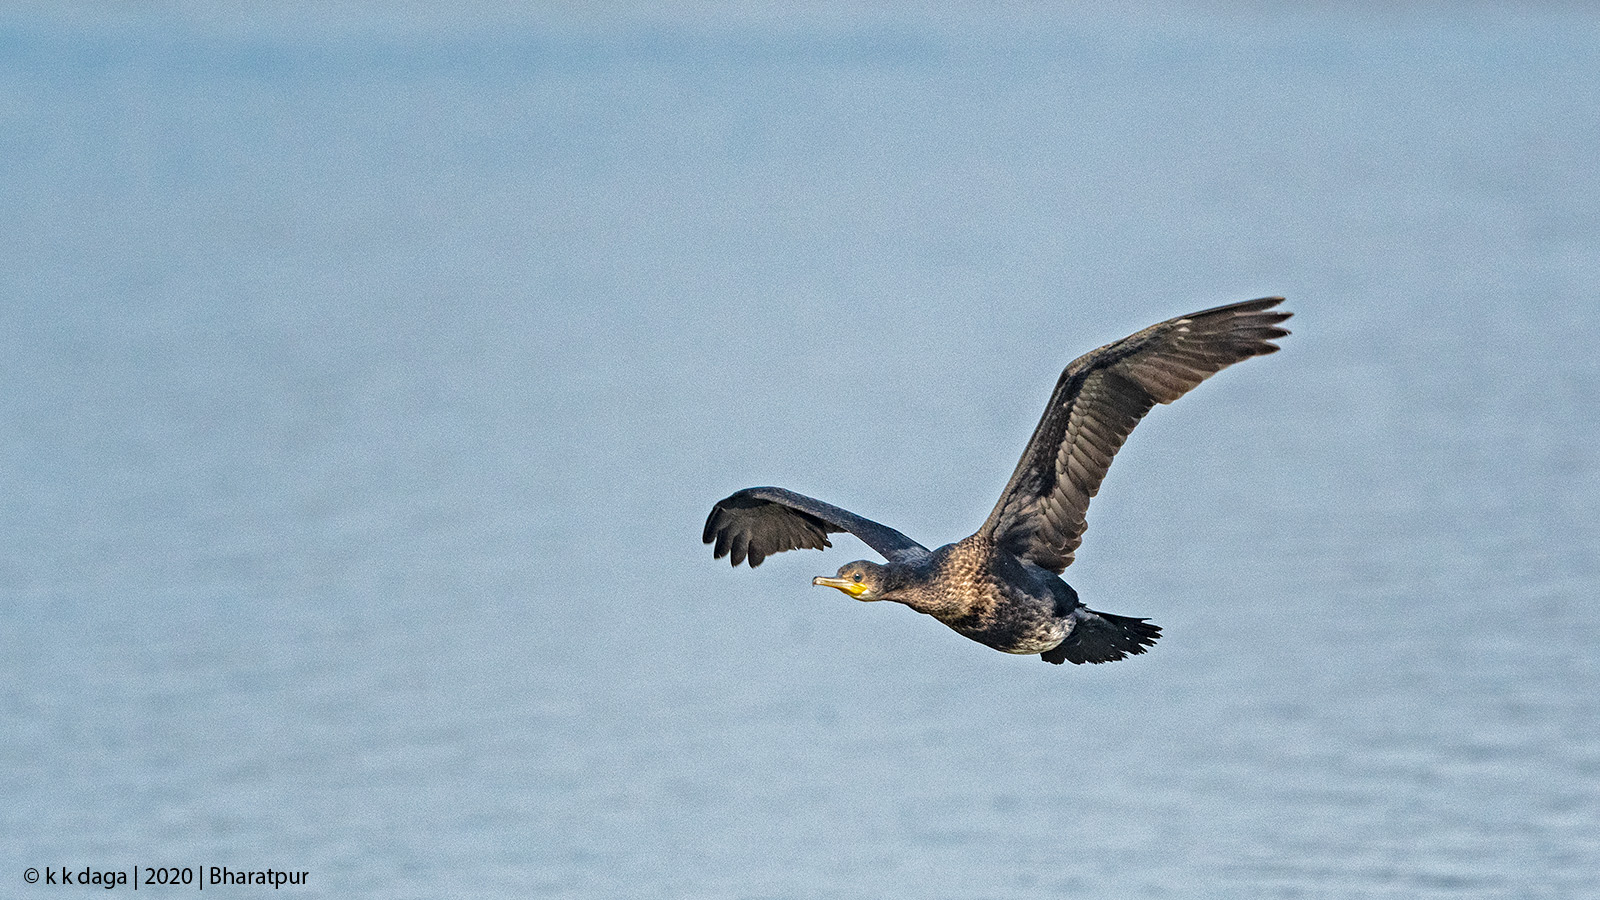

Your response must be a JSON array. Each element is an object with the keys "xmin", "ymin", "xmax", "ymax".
[{"xmin": 979, "ymin": 296, "xmax": 1290, "ymax": 573}]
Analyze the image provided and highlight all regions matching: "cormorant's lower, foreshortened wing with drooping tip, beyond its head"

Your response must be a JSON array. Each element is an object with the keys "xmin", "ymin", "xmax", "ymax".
[{"xmin": 701, "ymin": 487, "xmax": 928, "ymax": 569}]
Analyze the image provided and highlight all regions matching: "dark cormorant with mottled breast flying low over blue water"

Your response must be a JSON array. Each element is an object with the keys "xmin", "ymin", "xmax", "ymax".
[{"xmin": 702, "ymin": 296, "xmax": 1291, "ymax": 665}]
